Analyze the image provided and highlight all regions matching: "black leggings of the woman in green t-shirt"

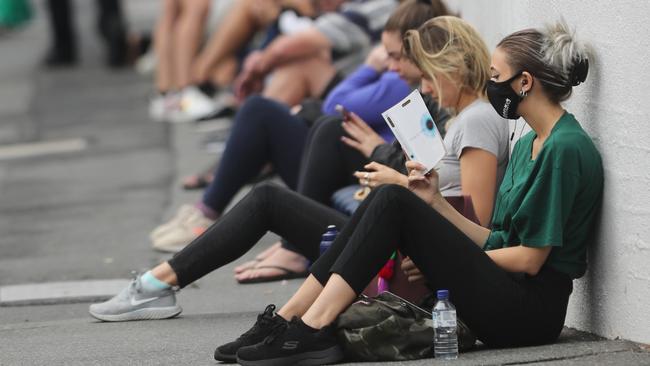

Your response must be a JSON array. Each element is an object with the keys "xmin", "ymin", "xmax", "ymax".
[{"xmin": 311, "ymin": 185, "xmax": 572, "ymax": 347}]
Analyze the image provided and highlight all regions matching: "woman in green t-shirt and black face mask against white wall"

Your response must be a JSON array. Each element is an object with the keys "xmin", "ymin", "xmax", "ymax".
[{"xmin": 229, "ymin": 20, "xmax": 603, "ymax": 365}]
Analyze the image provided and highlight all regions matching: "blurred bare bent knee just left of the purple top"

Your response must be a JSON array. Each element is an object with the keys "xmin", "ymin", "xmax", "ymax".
[{"xmin": 263, "ymin": 56, "xmax": 336, "ymax": 106}]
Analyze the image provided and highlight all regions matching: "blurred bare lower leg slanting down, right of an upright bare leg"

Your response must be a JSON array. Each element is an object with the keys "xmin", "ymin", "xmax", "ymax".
[{"xmin": 193, "ymin": 0, "xmax": 280, "ymax": 83}]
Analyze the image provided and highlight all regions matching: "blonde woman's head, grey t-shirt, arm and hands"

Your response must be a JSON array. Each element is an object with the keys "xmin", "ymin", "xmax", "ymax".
[{"xmin": 343, "ymin": 20, "xmax": 509, "ymax": 226}]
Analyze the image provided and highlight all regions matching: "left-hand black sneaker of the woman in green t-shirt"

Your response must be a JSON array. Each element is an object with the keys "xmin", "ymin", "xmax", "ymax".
[{"xmin": 214, "ymin": 304, "xmax": 287, "ymax": 362}]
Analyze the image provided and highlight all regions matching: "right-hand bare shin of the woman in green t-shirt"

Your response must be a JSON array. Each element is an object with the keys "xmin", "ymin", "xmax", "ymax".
[{"xmin": 298, "ymin": 273, "xmax": 357, "ymax": 329}]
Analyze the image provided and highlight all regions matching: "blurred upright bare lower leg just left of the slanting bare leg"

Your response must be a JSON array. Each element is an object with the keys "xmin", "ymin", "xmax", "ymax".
[{"xmin": 173, "ymin": 0, "xmax": 210, "ymax": 88}]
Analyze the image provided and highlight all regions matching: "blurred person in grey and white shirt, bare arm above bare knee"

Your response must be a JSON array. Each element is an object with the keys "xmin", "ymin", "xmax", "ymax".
[{"xmin": 235, "ymin": 0, "xmax": 398, "ymax": 105}]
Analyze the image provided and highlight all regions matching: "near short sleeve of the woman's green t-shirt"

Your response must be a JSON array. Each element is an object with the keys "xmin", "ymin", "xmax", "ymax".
[{"xmin": 512, "ymin": 152, "xmax": 579, "ymax": 247}]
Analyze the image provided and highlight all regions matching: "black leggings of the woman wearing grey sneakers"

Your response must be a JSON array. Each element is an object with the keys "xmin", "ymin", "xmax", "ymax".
[{"xmin": 169, "ymin": 183, "xmax": 348, "ymax": 287}]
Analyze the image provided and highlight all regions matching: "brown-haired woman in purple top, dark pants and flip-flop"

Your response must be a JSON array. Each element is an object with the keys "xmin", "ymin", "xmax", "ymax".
[{"xmin": 235, "ymin": 0, "xmax": 458, "ymax": 283}]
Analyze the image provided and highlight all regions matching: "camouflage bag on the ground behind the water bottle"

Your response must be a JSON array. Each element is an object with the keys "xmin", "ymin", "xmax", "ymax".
[{"xmin": 337, "ymin": 292, "xmax": 476, "ymax": 361}]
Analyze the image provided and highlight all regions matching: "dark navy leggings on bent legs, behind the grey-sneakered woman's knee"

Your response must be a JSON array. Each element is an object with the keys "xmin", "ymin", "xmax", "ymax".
[{"xmin": 203, "ymin": 96, "xmax": 309, "ymax": 213}]
